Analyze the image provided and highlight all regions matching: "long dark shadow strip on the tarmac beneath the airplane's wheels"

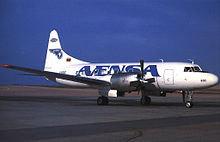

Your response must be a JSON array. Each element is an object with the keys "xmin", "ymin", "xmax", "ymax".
[{"xmin": 0, "ymin": 96, "xmax": 220, "ymax": 108}]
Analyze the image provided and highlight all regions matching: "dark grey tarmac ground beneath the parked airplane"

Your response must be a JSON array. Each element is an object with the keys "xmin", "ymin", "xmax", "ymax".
[{"xmin": 0, "ymin": 86, "xmax": 220, "ymax": 142}]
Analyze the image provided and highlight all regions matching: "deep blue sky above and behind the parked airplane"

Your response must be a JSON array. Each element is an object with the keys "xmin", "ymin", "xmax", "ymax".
[{"xmin": 0, "ymin": 0, "xmax": 220, "ymax": 85}]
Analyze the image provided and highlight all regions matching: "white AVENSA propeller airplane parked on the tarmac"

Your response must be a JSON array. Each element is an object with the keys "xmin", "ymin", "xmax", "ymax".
[{"xmin": 1, "ymin": 30, "xmax": 219, "ymax": 108}]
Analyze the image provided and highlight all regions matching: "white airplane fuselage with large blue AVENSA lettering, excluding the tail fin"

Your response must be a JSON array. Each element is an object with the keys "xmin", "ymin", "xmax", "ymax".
[{"xmin": 53, "ymin": 62, "xmax": 218, "ymax": 92}]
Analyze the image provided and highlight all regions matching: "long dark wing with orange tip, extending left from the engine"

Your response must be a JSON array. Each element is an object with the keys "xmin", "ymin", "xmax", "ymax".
[{"xmin": 1, "ymin": 65, "xmax": 110, "ymax": 86}]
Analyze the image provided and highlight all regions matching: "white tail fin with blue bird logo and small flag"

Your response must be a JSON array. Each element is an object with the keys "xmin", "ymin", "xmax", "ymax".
[{"xmin": 44, "ymin": 30, "xmax": 88, "ymax": 72}]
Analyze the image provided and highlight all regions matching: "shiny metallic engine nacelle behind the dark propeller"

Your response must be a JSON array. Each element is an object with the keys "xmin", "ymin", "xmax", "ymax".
[{"xmin": 111, "ymin": 73, "xmax": 138, "ymax": 92}]
